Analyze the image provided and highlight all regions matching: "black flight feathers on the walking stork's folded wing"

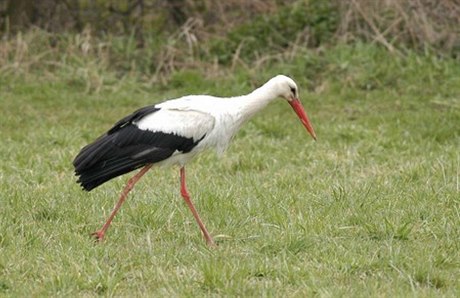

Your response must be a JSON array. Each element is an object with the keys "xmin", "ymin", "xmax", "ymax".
[{"xmin": 73, "ymin": 106, "xmax": 204, "ymax": 191}]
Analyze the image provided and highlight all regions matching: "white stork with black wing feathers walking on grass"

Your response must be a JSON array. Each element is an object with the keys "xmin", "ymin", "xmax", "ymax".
[{"xmin": 73, "ymin": 75, "xmax": 316, "ymax": 245}]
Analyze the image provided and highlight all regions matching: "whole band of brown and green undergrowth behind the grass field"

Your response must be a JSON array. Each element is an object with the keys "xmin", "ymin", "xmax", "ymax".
[{"xmin": 0, "ymin": 0, "xmax": 460, "ymax": 85}]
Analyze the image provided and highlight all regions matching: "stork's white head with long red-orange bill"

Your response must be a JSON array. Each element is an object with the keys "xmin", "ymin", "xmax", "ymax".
[{"xmin": 270, "ymin": 75, "xmax": 316, "ymax": 140}]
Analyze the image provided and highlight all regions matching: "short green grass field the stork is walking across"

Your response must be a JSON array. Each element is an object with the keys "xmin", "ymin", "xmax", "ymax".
[{"xmin": 0, "ymin": 45, "xmax": 460, "ymax": 297}]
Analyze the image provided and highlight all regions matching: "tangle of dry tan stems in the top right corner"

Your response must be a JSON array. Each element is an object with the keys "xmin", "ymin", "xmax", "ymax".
[{"xmin": 338, "ymin": 0, "xmax": 460, "ymax": 55}]
